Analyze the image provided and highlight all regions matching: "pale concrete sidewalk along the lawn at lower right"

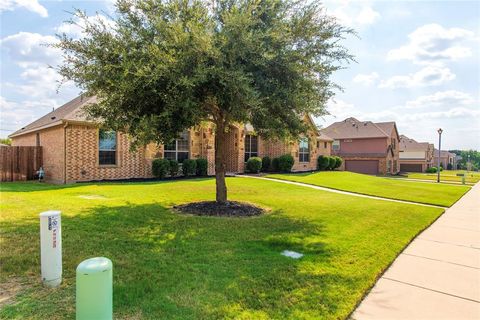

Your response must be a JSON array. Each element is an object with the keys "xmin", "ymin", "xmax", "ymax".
[{"xmin": 352, "ymin": 183, "xmax": 480, "ymax": 320}]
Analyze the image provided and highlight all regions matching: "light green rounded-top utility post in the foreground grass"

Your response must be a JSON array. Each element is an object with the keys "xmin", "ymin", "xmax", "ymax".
[{"xmin": 76, "ymin": 257, "xmax": 113, "ymax": 320}]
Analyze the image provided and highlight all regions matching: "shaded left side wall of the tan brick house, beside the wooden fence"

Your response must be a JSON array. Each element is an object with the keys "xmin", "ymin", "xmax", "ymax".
[{"xmin": 12, "ymin": 125, "xmax": 65, "ymax": 183}]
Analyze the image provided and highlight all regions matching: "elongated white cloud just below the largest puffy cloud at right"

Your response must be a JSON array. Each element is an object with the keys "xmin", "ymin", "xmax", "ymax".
[{"xmin": 379, "ymin": 65, "xmax": 456, "ymax": 89}]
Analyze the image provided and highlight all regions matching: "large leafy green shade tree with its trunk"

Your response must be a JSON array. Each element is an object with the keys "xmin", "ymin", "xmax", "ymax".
[{"xmin": 54, "ymin": 0, "xmax": 352, "ymax": 202}]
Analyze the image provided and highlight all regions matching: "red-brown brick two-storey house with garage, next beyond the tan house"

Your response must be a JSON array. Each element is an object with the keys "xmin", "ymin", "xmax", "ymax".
[{"xmin": 321, "ymin": 118, "xmax": 399, "ymax": 174}]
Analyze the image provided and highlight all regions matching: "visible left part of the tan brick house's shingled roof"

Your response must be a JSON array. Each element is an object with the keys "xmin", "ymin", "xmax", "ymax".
[{"xmin": 9, "ymin": 95, "xmax": 97, "ymax": 137}]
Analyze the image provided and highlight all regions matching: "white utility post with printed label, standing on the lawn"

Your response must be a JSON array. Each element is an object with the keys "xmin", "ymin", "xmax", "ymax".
[{"xmin": 40, "ymin": 211, "xmax": 62, "ymax": 287}]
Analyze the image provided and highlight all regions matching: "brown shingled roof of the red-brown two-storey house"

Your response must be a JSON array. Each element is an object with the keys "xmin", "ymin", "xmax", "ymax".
[{"xmin": 320, "ymin": 117, "xmax": 396, "ymax": 139}]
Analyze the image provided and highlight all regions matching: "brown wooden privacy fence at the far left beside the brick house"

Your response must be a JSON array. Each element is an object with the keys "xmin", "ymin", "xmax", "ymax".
[{"xmin": 0, "ymin": 146, "xmax": 42, "ymax": 181}]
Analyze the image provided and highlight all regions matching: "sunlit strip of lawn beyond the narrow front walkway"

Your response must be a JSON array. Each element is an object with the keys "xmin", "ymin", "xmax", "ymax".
[{"xmin": 267, "ymin": 171, "xmax": 470, "ymax": 207}]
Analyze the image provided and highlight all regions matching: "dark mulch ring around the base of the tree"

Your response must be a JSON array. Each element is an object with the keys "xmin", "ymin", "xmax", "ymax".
[{"xmin": 173, "ymin": 201, "xmax": 265, "ymax": 217}]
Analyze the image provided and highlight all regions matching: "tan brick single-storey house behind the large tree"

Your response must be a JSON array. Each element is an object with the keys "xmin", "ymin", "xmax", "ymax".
[{"xmin": 10, "ymin": 96, "xmax": 333, "ymax": 183}]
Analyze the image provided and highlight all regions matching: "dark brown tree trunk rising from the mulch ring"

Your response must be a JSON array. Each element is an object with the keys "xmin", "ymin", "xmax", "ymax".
[{"xmin": 215, "ymin": 123, "xmax": 227, "ymax": 203}]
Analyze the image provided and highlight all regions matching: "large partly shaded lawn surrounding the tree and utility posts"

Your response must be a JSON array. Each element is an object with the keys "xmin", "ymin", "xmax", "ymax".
[{"xmin": 0, "ymin": 178, "xmax": 443, "ymax": 319}]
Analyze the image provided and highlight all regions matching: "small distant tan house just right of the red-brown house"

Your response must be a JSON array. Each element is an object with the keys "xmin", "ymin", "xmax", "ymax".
[{"xmin": 399, "ymin": 135, "xmax": 434, "ymax": 172}]
